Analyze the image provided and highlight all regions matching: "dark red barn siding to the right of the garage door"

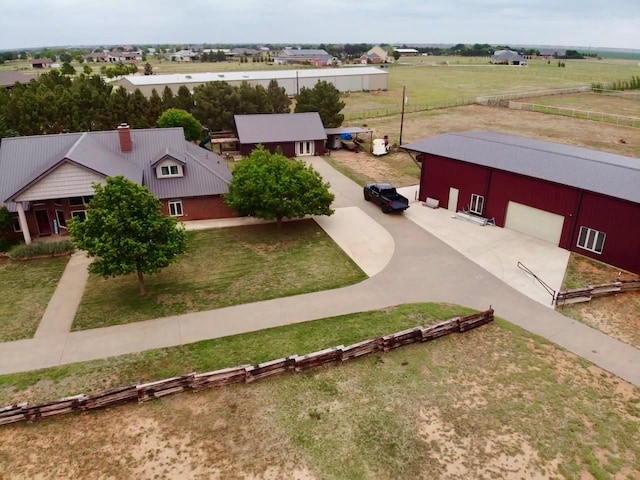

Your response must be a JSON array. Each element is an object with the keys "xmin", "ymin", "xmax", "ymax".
[{"xmin": 570, "ymin": 192, "xmax": 640, "ymax": 273}]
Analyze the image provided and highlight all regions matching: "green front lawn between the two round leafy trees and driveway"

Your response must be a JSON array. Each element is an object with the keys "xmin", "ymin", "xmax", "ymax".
[{"xmin": 73, "ymin": 220, "xmax": 366, "ymax": 330}]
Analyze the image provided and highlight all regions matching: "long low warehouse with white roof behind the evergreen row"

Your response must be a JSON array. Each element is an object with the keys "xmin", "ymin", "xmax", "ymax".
[{"xmin": 115, "ymin": 67, "xmax": 389, "ymax": 96}]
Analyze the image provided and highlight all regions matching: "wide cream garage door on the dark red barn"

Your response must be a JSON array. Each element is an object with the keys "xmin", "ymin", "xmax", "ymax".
[{"xmin": 504, "ymin": 202, "xmax": 564, "ymax": 245}]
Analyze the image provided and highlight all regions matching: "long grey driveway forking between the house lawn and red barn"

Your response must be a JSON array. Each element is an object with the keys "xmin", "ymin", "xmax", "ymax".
[{"xmin": 0, "ymin": 158, "xmax": 640, "ymax": 385}]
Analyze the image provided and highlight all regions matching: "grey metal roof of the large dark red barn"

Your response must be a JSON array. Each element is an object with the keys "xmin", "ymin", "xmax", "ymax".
[{"xmin": 402, "ymin": 132, "xmax": 640, "ymax": 203}]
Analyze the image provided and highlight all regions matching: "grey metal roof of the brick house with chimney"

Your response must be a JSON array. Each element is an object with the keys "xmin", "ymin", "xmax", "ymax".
[{"xmin": 0, "ymin": 128, "xmax": 231, "ymax": 211}]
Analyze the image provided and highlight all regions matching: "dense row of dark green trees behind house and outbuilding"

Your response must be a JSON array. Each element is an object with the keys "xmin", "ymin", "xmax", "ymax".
[{"xmin": 0, "ymin": 70, "xmax": 344, "ymax": 138}]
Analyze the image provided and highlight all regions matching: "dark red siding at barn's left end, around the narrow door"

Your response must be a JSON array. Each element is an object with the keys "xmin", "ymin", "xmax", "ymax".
[{"xmin": 419, "ymin": 154, "xmax": 489, "ymax": 210}]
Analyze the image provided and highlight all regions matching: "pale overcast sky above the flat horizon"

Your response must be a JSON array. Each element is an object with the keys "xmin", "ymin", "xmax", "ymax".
[{"xmin": 0, "ymin": 0, "xmax": 640, "ymax": 50}]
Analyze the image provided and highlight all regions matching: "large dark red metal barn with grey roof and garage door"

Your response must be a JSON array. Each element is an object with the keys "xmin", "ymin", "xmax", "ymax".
[{"xmin": 402, "ymin": 132, "xmax": 640, "ymax": 273}]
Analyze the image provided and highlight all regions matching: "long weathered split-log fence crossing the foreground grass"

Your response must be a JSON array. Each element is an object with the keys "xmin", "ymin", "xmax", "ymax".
[{"xmin": 0, "ymin": 308, "xmax": 493, "ymax": 425}]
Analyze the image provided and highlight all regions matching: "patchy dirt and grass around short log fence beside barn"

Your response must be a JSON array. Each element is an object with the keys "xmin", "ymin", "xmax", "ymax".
[{"xmin": 558, "ymin": 254, "xmax": 640, "ymax": 348}]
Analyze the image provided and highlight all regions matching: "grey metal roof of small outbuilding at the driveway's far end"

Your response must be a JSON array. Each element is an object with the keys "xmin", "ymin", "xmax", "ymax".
[{"xmin": 234, "ymin": 112, "xmax": 327, "ymax": 144}]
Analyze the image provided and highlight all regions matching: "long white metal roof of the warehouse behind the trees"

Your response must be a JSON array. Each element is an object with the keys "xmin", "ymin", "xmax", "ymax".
[{"xmin": 119, "ymin": 67, "xmax": 389, "ymax": 86}]
